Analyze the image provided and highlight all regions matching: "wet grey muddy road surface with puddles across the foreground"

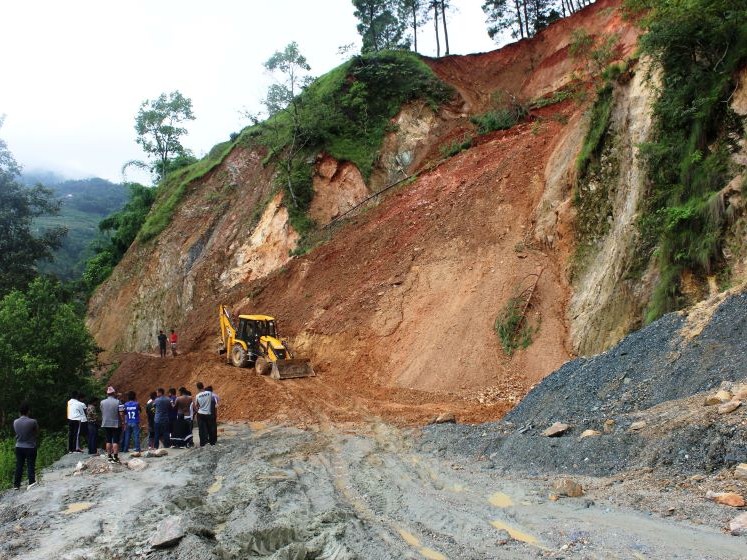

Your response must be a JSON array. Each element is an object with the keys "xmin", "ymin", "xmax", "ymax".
[{"xmin": 0, "ymin": 422, "xmax": 747, "ymax": 560}]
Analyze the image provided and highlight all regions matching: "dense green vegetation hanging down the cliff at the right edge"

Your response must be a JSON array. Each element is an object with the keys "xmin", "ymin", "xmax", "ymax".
[{"xmin": 626, "ymin": 0, "xmax": 747, "ymax": 321}]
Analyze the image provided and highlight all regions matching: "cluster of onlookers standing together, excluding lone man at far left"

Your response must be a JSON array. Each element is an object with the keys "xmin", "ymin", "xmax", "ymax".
[{"xmin": 67, "ymin": 382, "xmax": 220, "ymax": 463}]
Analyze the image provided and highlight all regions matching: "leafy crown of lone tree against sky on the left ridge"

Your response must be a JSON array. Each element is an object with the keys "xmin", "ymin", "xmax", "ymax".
[{"xmin": 130, "ymin": 91, "xmax": 195, "ymax": 180}]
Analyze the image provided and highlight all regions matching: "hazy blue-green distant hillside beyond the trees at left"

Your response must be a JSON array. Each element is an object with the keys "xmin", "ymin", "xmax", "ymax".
[{"xmin": 30, "ymin": 176, "xmax": 128, "ymax": 280}]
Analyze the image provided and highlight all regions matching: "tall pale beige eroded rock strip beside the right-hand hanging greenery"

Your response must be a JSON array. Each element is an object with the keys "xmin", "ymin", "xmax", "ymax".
[{"xmin": 568, "ymin": 65, "xmax": 654, "ymax": 355}]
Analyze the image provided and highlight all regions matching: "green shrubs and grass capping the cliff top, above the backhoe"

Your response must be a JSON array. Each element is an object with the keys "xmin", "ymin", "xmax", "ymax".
[{"xmin": 237, "ymin": 48, "xmax": 452, "ymax": 251}]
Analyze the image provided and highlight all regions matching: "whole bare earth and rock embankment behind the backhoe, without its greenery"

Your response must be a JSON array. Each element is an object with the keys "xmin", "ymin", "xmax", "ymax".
[{"xmin": 89, "ymin": 1, "xmax": 636, "ymax": 421}]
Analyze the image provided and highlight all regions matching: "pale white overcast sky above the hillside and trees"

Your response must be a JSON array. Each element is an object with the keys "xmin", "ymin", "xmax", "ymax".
[{"xmin": 0, "ymin": 0, "xmax": 502, "ymax": 182}]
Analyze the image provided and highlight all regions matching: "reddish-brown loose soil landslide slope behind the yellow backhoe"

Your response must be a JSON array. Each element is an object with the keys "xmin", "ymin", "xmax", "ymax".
[{"xmin": 106, "ymin": 1, "xmax": 634, "ymax": 423}]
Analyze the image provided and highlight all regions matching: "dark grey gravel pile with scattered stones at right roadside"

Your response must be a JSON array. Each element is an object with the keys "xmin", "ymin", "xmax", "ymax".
[{"xmin": 420, "ymin": 294, "xmax": 747, "ymax": 476}]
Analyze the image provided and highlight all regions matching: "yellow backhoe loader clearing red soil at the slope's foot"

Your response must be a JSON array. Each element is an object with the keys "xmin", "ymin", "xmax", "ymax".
[{"xmin": 218, "ymin": 305, "xmax": 316, "ymax": 379}]
